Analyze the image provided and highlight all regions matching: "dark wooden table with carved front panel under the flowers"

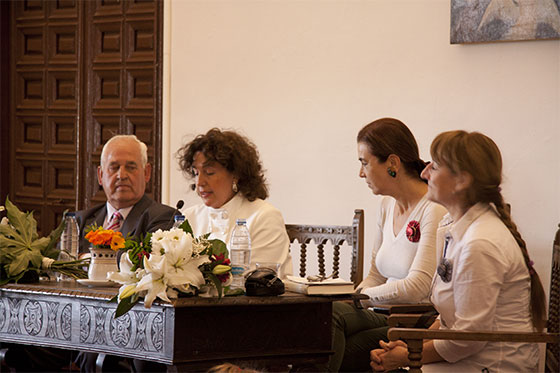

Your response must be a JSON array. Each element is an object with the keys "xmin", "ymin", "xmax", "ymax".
[{"xmin": 0, "ymin": 282, "xmax": 346, "ymax": 371}]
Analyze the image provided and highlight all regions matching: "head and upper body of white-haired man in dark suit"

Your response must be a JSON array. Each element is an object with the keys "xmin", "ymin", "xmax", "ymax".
[{"xmin": 76, "ymin": 135, "xmax": 175, "ymax": 253}]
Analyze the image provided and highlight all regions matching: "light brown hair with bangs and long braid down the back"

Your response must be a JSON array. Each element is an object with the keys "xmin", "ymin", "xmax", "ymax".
[{"xmin": 430, "ymin": 131, "xmax": 546, "ymax": 331}]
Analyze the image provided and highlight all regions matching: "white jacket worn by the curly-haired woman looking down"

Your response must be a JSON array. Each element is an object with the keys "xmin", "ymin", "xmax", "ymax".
[{"xmin": 185, "ymin": 194, "xmax": 293, "ymax": 277}]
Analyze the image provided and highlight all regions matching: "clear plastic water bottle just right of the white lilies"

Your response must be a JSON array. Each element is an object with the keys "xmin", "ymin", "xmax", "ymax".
[{"xmin": 229, "ymin": 219, "xmax": 251, "ymax": 289}]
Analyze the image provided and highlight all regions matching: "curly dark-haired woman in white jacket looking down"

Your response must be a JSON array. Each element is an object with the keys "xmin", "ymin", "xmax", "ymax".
[{"xmin": 177, "ymin": 128, "xmax": 292, "ymax": 277}]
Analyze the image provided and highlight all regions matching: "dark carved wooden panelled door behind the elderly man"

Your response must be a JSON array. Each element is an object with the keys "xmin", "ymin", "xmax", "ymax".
[{"xmin": 9, "ymin": 0, "xmax": 163, "ymax": 234}]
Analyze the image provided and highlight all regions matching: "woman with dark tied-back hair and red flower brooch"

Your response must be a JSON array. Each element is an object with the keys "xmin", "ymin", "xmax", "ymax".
[{"xmin": 329, "ymin": 118, "xmax": 445, "ymax": 371}]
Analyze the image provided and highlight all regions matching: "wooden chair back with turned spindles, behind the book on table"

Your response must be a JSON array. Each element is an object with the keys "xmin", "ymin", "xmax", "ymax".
[{"xmin": 286, "ymin": 209, "xmax": 364, "ymax": 286}]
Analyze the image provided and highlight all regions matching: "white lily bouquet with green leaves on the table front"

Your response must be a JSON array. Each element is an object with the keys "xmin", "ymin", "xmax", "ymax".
[{"xmin": 107, "ymin": 221, "xmax": 231, "ymax": 318}]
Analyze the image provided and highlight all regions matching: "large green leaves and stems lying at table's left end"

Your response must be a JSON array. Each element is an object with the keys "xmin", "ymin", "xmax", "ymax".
[{"xmin": 0, "ymin": 198, "xmax": 89, "ymax": 285}]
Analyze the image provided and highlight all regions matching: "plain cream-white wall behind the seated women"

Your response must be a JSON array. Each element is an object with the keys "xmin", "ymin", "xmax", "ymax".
[{"xmin": 163, "ymin": 0, "xmax": 560, "ymax": 290}]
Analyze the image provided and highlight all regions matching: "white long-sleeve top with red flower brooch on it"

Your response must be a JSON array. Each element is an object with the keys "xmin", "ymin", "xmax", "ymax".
[{"xmin": 359, "ymin": 197, "xmax": 446, "ymax": 303}]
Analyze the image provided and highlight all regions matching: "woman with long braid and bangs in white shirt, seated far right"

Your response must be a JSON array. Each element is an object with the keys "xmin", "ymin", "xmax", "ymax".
[{"xmin": 370, "ymin": 131, "xmax": 546, "ymax": 372}]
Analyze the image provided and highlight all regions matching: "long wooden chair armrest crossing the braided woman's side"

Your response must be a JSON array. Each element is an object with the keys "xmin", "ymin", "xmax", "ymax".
[{"xmin": 387, "ymin": 328, "xmax": 560, "ymax": 343}]
